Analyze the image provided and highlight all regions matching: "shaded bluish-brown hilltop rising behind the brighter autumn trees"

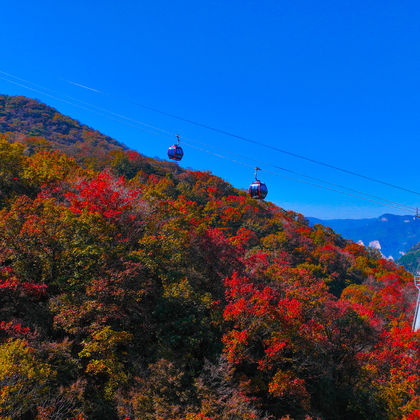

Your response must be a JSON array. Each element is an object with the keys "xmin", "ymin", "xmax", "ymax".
[{"xmin": 0, "ymin": 95, "xmax": 180, "ymax": 177}]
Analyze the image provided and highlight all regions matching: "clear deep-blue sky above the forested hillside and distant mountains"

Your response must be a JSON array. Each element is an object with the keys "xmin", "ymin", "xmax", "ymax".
[{"xmin": 0, "ymin": 0, "xmax": 420, "ymax": 218}]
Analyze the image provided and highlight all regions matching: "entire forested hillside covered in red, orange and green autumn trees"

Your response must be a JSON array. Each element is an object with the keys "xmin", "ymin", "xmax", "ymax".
[{"xmin": 0, "ymin": 97, "xmax": 420, "ymax": 420}]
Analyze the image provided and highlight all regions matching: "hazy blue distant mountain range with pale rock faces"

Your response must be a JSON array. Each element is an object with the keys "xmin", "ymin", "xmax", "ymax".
[{"xmin": 307, "ymin": 214, "xmax": 420, "ymax": 260}]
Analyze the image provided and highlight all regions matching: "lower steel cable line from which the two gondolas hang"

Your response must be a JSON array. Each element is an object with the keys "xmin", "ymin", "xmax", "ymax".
[{"xmin": 0, "ymin": 71, "xmax": 415, "ymax": 211}]
